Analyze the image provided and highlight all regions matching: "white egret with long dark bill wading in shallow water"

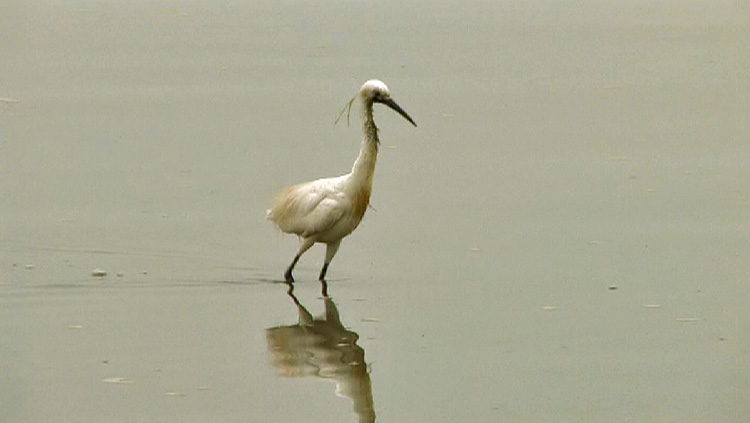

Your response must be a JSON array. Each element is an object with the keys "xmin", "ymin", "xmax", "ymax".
[{"xmin": 266, "ymin": 79, "xmax": 417, "ymax": 283}]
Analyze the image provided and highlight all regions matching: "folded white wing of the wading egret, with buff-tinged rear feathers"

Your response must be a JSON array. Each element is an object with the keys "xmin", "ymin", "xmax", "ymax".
[{"xmin": 268, "ymin": 178, "xmax": 350, "ymax": 237}]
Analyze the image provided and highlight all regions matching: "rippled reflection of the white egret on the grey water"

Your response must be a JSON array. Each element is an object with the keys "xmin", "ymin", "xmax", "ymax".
[{"xmin": 266, "ymin": 281, "xmax": 375, "ymax": 423}]
